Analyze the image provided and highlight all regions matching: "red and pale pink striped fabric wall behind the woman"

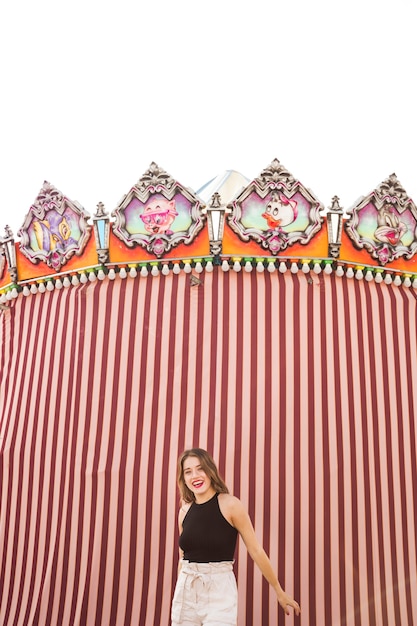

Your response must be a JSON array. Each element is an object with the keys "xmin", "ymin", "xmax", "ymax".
[{"xmin": 0, "ymin": 268, "xmax": 417, "ymax": 626}]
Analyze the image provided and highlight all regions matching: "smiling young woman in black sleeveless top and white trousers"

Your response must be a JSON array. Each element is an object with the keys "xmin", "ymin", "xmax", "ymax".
[{"xmin": 171, "ymin": 448, "xmax": 300, "ymax": 626}]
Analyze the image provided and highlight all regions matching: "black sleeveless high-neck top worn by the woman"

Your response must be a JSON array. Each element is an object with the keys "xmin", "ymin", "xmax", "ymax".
[{"xmin": 179, "ymin": 493, "xmax": 237, "ymax": 563}]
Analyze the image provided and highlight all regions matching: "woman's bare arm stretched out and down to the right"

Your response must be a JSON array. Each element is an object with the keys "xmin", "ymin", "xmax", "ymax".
[{"xmin": 222, "ymin": 496, "xmax": 300, "ymax": 615}]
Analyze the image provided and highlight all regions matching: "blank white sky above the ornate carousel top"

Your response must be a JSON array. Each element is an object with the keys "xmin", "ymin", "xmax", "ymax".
[{"xmin": 0, "ymin": 0, "xmax": 417, "ymax": 236}]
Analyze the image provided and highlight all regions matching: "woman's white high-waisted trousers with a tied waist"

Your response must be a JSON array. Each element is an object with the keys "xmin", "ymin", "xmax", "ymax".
[{"xmin": 171, "ymin": 561, "xmax": 237, "ymax": 626}]
